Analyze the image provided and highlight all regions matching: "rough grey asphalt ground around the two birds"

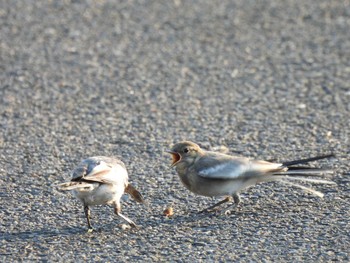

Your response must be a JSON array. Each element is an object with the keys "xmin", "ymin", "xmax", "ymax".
[{"xmin": 0, "ymin": 0, "xmax": 350, "ymax": 262}]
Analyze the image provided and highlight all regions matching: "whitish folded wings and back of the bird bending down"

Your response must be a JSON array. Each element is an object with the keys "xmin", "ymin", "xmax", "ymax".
[{"xmin": 72, "ymin": 157, "xmax": 127, "ymax": 184}]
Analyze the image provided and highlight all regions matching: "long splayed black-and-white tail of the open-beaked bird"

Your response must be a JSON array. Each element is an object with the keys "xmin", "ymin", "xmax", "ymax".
[{"xmin": 272, "ymin": 154, "xmax": 336, "ymax": 198}]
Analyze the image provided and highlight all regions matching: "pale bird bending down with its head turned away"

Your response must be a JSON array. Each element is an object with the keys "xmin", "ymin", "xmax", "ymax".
[{"xmin": 57, "ymin": 156, "xmax": 144, "ymax": 232}]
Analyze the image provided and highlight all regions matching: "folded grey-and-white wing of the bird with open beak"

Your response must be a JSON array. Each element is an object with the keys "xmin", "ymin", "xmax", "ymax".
[{"xmin": 194, "ymin": 154, "xmax": 281, "ymax": 180}]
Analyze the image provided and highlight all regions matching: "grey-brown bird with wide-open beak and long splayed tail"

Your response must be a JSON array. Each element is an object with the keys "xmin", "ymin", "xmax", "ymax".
[{"xmin": 167, "ymin": 141, "xmax": 335, "ymax": 213}]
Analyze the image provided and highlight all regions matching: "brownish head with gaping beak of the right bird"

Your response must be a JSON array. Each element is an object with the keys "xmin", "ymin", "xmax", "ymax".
[{"xmin": 168, "ymin": 141, "xmax": 203, "ymax": 167}]
